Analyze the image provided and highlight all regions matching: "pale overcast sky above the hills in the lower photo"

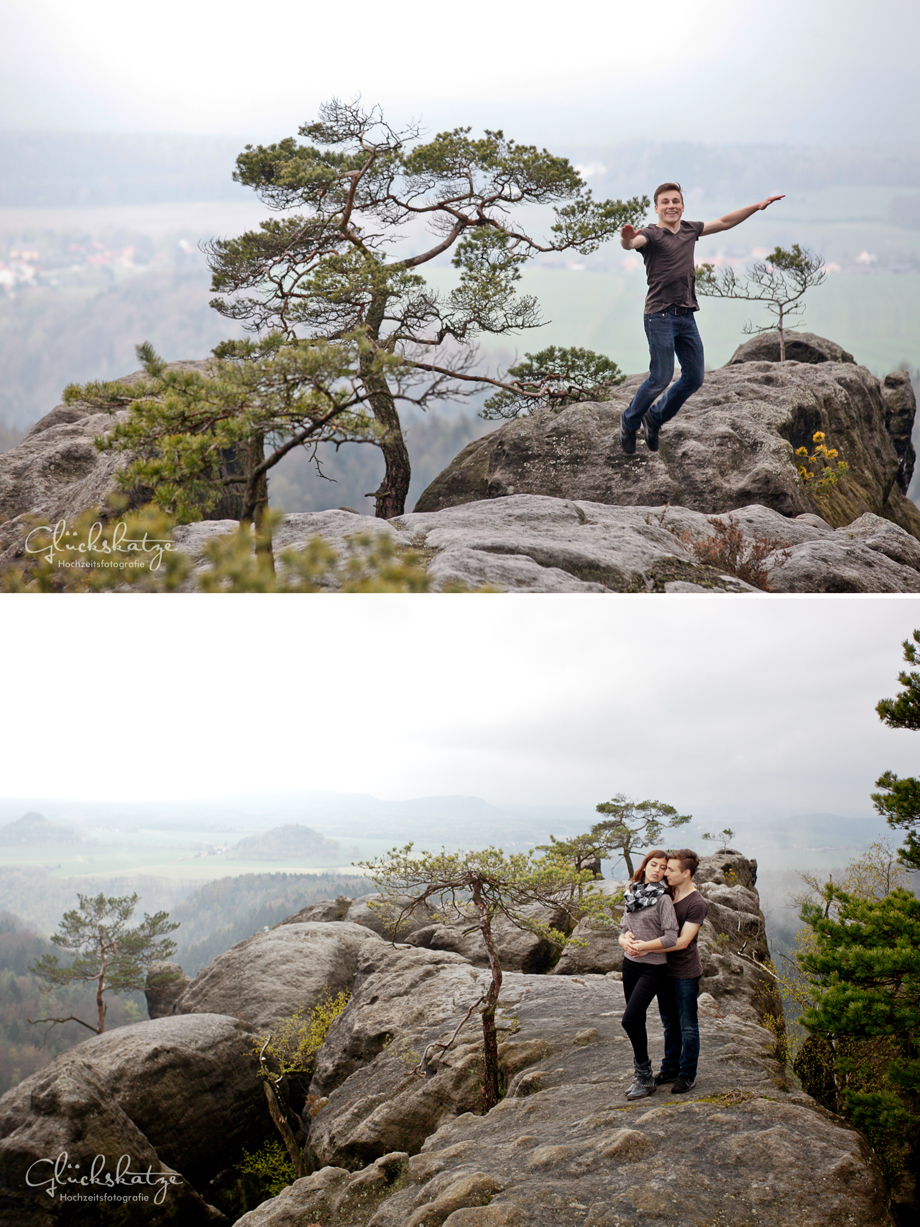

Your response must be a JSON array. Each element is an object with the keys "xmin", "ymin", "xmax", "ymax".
[{"xmin": 0, "ymin": 595, "xmax": 920, "ymax": 822}]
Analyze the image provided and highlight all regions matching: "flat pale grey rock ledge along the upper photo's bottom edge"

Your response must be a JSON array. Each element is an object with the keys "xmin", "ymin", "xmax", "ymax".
[{"xmin": 165, "ymin": 494, "xmax": 920, "ymax": 593}]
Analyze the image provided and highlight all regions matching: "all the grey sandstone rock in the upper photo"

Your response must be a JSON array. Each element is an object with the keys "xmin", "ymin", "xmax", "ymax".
[{"xmin": 0, "ymin": 333, "xmax": 920, "ymax": 593}]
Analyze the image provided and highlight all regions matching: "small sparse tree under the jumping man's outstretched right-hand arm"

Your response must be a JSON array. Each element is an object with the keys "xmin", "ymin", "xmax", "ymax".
[{"xmin": 697, "ymin": 243, "xmax": 827, "ymax": 362}]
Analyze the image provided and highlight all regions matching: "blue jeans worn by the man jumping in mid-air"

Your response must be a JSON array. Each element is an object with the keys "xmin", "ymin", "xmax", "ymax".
[{"xmin": 621, "ymin": 312, "xmax": 705, "ymax": 432}]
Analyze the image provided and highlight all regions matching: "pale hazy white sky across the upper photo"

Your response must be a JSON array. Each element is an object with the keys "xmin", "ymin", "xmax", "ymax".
[{"xmin": 0, "ymin": 0, "xmax": 920, "ymax": 146}]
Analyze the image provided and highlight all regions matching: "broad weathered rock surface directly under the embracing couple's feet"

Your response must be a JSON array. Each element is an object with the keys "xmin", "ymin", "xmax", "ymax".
[{"xmin": 239, "ymin": 974, "xmax": 892, "ymax": 1227}]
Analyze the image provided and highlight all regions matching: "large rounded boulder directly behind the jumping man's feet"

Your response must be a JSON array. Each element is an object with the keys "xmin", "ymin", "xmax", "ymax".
[{"xmin": 416, "ymin": 334, "xmax": 920, "ymax": 536}]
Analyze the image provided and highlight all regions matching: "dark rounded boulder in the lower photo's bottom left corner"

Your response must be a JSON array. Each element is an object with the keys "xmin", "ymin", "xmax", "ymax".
[{"xmin": 0, "ymin": 1015, "xmax": 271, "ymax": 1225}]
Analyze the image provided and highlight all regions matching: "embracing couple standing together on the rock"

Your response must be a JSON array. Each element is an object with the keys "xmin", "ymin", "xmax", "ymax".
[{"xmin": 619, "ymin": 848, "xmax": 709, "ymax": 1099}]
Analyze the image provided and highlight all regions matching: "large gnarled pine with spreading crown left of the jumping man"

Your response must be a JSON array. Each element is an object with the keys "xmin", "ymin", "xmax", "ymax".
[{"xmin": 206, "ymin": 99, "xmax": 648, "ymax": 518}]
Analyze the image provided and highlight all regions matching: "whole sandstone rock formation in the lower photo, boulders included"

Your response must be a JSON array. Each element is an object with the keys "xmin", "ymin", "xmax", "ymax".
[{"xmin": 0, "ymin": 849, "xmax": 892, "ymax": 1227}]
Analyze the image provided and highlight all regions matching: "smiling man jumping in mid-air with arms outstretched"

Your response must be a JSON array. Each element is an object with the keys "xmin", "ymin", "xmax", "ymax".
[{"xmin": 619, "ymin": 183, "xmax": 783, "ymax": 455}]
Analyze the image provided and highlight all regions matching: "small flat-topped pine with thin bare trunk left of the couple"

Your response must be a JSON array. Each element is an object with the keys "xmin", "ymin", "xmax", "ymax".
[{"xmin": 361, "ymin": 843, "xmax": 610, "ymax": 1110}]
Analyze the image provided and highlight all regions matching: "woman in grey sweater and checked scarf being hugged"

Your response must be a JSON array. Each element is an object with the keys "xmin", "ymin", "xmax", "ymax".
[{"xmin": 619, "ymin": 848, "xmax": 677, "ymax": 1099}]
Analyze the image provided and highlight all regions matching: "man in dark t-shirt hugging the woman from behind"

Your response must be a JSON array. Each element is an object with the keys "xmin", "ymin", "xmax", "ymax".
[{"xmin": 626, "ymin": 848, "xmax": 709, "ymax": 1094}]
